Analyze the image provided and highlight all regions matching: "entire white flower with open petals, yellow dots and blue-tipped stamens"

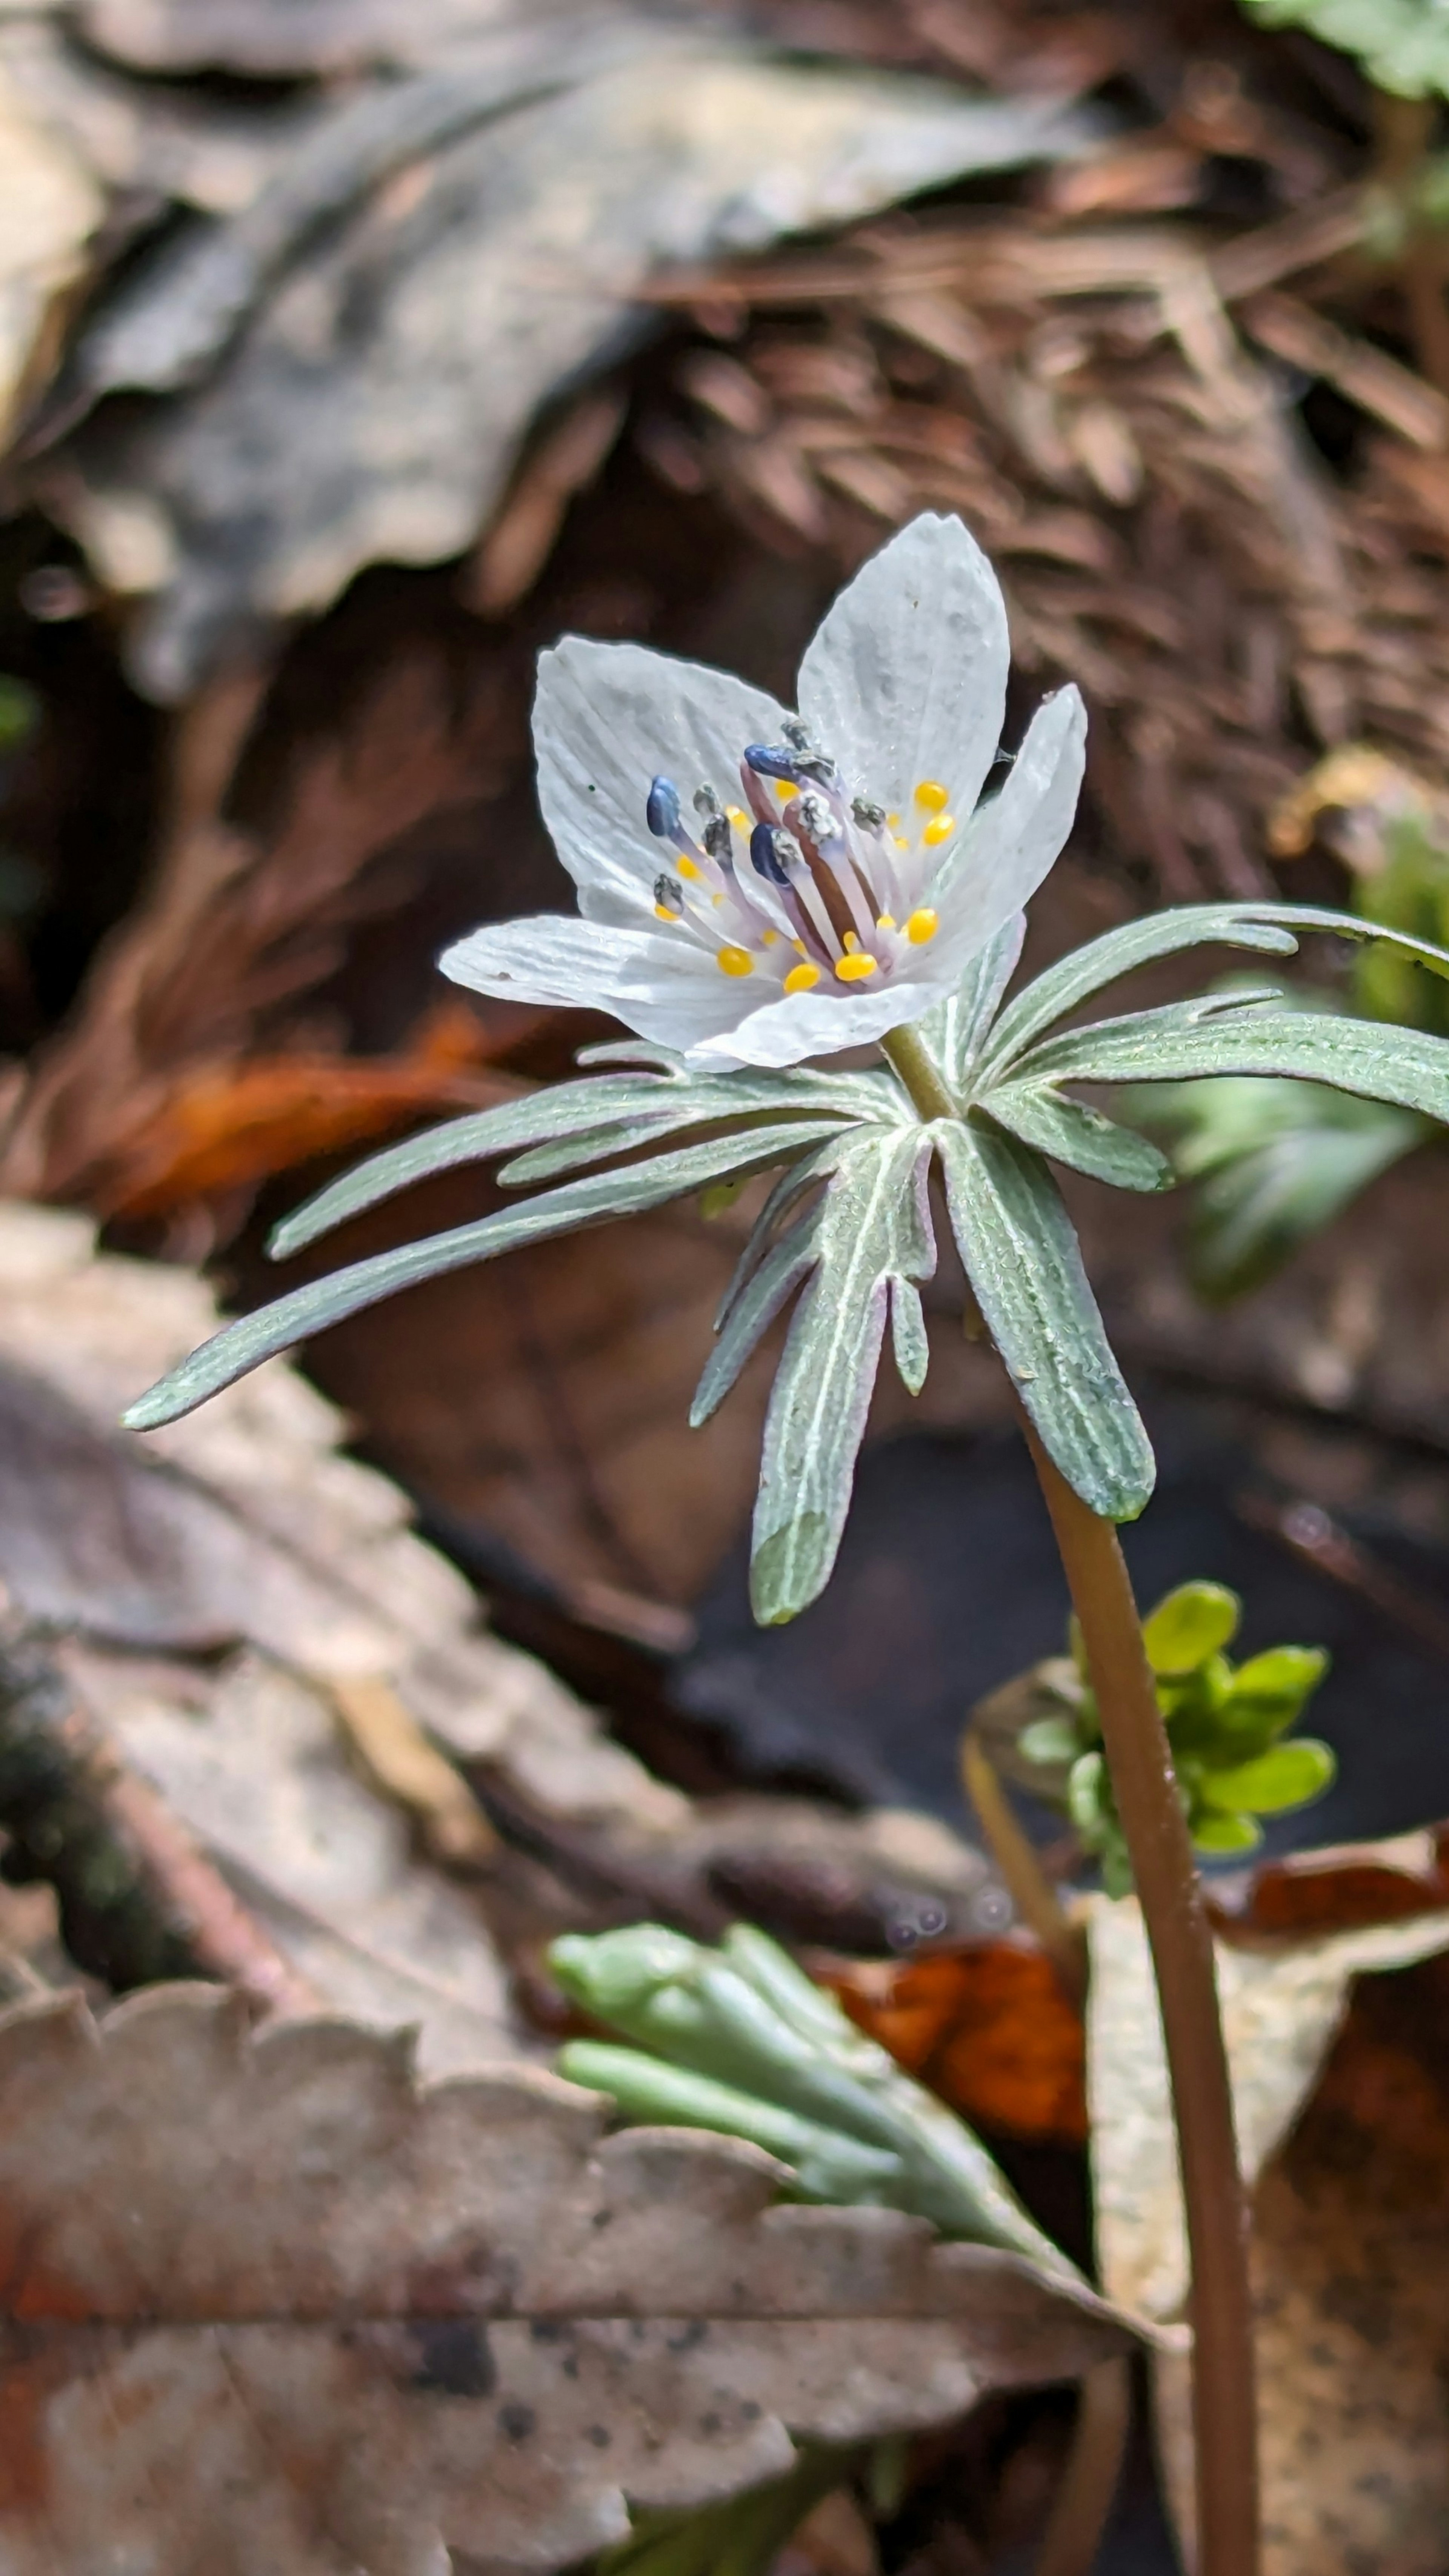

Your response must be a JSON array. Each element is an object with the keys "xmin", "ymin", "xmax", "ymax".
[{"xmin": 441, "ymin": 518, "xmax": 1086, "ymax": 1072}]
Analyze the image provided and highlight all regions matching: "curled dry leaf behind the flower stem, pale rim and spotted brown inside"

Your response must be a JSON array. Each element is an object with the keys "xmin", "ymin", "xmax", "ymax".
[{"xmin": 1088, "ymin": 1898, "xmax": 1449, "ymax": 2576}]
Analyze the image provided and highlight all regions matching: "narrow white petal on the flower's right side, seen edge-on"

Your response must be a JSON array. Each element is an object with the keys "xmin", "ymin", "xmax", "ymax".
[{"xmin": 926, "ymin": 688, "xmax": 1086, "ymax": 966}]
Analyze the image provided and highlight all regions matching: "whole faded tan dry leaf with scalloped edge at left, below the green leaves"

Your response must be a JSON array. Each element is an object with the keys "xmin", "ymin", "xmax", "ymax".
[{"xmin": 0, "ymin": 1208, "xmax": 711, "ymax": 2068}]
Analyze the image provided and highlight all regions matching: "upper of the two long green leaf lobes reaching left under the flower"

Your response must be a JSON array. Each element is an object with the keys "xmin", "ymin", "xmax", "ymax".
[{"xmin": 268, "ymin": 1059, "xmax": 887, "ymax": 1260}]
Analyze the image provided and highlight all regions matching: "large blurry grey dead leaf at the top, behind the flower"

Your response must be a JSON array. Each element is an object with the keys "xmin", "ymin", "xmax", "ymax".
[{"xmin": 41, "ymin": 58, "xmax": 1088, "ymax": 698}]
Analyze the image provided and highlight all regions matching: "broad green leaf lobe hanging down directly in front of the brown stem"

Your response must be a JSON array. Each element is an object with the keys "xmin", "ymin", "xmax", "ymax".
[{"xmin": 931, "ymin": 1121, "xmax": 1155, "ymax": 1520}]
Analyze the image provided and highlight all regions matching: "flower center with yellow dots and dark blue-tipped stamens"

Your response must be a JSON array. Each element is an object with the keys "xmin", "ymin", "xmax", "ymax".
[{"xmin": 645, "ymin": 719, "xmax": 957, "ymax": 992}]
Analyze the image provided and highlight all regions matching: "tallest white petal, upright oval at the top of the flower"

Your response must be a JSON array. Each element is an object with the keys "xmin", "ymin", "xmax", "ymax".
[{"xmin": 799, "ymin": 515, "xmax": 1011, "ymax": 817}]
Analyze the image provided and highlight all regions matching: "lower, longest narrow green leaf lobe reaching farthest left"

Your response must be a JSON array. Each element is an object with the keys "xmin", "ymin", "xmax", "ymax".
[{"xmin": 124, "ymin": 1118, "xmax": 833, "ymax": 1430}]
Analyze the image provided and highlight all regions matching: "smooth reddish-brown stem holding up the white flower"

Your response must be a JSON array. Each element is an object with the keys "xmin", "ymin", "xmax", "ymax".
[{"xmin": 882, "ymin": 1028, "xmax": 1258, "ymax": 2576}]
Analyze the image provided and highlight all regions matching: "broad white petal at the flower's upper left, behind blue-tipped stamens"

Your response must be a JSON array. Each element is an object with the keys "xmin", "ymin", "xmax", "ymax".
[{"xmin": 534, "ymin": 636, "xmax": 784, "ymax": 922}]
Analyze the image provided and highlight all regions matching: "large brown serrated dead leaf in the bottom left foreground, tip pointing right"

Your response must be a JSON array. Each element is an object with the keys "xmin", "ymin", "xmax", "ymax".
[{"xmin": 0, "ymin": 1986, "xmax": 1129, "ymax": 2576}]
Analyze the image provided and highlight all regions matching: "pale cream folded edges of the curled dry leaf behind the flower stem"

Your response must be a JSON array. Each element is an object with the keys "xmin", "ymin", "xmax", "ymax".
[{"xmin": 1088, "ymin": 1896, "xmax": 1449, "ymax": 2324}]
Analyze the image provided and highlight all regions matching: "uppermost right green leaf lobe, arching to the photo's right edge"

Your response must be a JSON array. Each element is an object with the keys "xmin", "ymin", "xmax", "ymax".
[{"xmin": 977, "ymin": 904, "xmax": 1449, "ymax": 1097}]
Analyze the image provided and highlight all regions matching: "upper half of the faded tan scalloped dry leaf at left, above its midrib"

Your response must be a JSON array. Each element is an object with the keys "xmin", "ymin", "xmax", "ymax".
[{"xmin": 0, "ymin": 1203, "xmax": 688, "ymax": 1832}]
